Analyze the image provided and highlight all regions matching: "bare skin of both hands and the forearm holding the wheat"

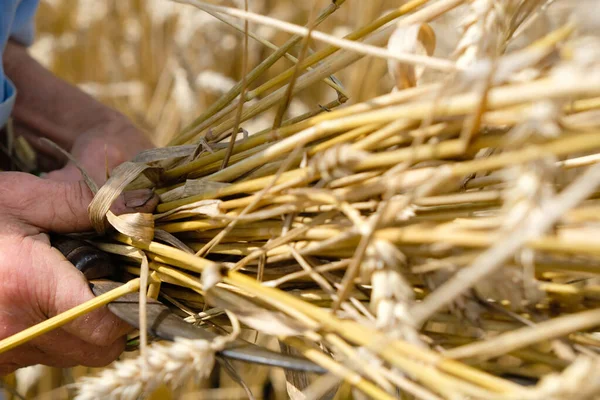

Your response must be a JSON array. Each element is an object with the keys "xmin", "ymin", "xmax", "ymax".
[{"xmin": 0, "ymin": 42, "xmax": 156, "ymax": 376}]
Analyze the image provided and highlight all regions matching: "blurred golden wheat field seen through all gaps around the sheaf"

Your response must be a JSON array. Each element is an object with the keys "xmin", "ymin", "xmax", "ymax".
[{"xmin": 0, "ymin": 0, "xmax": 597, "ymax": 400}]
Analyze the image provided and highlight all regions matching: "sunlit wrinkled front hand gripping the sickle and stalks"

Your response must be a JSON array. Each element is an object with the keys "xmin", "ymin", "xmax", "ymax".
[{"xmin": 0, "ymin": 172, "xmax": 155, "ymax": 375}]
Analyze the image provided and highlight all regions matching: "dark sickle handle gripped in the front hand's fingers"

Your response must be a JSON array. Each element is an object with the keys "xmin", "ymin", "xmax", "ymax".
[{"xmin": 50, "ymin": 234, "xmax": 117, "ymax": 280}]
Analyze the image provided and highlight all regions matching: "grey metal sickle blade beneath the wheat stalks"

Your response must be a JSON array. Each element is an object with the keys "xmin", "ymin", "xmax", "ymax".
[{"xmin": 91, "ymin": 280, "xmax": 326, "ymax": 374}]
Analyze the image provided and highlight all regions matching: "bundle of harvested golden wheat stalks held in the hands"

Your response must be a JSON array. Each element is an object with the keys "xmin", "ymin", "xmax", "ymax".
[{"xmin": 0, "ymin": 0, "xmax": 600, "ymax": 400}]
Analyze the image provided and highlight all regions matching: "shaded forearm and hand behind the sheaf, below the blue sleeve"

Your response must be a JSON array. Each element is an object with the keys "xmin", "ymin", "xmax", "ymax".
[{"xmin": 3, "ymin": 41, "xmax": 153, "ymax": 184}]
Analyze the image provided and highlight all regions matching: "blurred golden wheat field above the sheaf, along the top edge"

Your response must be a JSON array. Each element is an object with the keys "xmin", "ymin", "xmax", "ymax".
[{"xmin": 31, "ymin": 0, "xmax": 459, "ymax": 146}]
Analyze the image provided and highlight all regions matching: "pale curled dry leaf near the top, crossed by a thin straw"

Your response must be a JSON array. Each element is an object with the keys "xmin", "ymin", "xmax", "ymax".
[{"xmin": 388, "ymin": 23, "xmax": 435, "ymax": 90}]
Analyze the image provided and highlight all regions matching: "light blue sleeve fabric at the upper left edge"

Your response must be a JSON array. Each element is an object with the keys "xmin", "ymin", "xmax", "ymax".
[{"xmin": 0, "ymin": 0, "xmax": 38, "ymax": 127}]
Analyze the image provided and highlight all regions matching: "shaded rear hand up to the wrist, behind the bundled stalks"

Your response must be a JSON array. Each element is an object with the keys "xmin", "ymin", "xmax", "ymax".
[{"xmin": 47, "ymin": 119, "xmax": 153, "ymax": 185}]
